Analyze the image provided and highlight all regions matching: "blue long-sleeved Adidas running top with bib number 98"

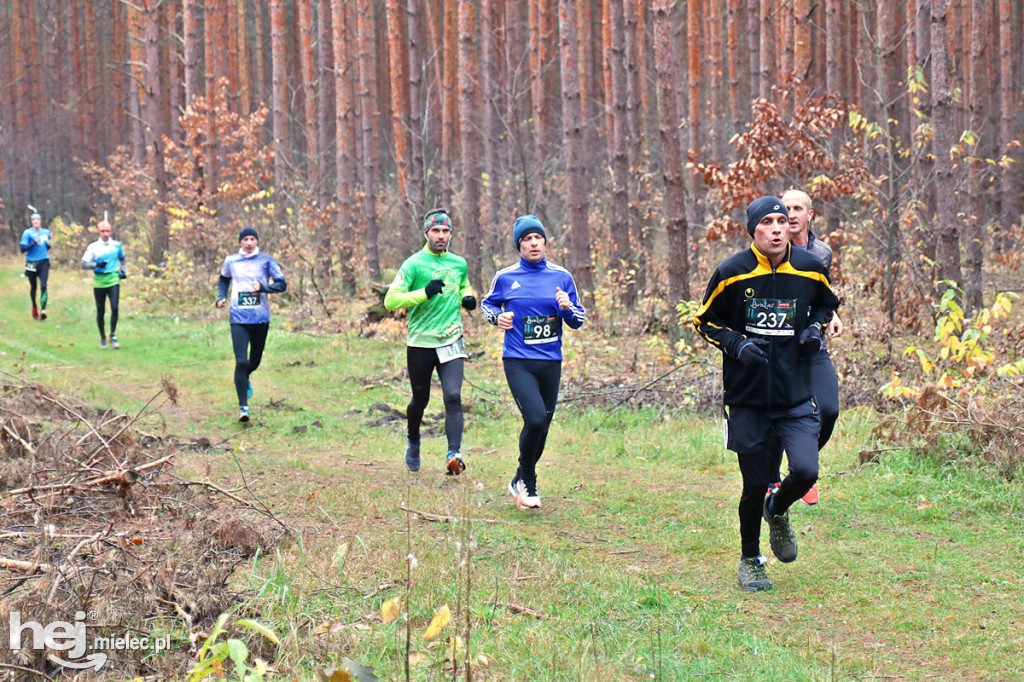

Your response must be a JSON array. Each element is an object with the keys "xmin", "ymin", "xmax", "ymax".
[{"xmin": 480, "ymin": 258, "xmax": 587, "ymax": 361}]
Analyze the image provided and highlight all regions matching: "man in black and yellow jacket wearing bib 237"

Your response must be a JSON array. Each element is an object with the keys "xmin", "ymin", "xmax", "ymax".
[{"xmin": 693, "ymin": 197, "xmax": 839, "ymax": 591}]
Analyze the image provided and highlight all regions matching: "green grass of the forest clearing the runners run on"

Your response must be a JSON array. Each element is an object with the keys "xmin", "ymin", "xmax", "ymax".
[{"xmin": 0, "ymin": 258, "xmax": 1024, "ymax": 680}]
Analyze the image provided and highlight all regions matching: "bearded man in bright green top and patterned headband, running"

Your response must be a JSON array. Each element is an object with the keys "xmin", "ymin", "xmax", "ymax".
[{"xmin": 384, "ymin": 209, "xmax": 476, "ymax": 475}]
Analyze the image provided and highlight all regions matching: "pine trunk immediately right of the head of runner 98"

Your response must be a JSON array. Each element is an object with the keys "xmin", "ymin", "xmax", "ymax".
[{"xmin": 558, "ymin": 0, "xmax": 594, "ymax": 301}]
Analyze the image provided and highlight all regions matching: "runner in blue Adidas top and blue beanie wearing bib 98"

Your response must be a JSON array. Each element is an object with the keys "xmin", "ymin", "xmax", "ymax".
[{"xmin": 481, "ymin": 215, "xmax": 587, "ymax": 509}]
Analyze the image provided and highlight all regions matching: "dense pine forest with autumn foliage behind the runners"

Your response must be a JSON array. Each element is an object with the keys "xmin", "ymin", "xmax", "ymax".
[{"xmin": 0, "ymin": 0, "xmax": 1024, "ymax": 315}]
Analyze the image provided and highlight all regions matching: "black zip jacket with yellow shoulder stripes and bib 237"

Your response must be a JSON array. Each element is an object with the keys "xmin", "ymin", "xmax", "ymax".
[{"xmin": 693, "ymin": 245, "xmax": 839, "ymax": 410}]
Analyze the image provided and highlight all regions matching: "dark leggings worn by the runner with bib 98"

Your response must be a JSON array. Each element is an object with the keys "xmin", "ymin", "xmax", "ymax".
[{"xmin": 505, "ymin": 357, "xmax": 562, "ymax": 484}]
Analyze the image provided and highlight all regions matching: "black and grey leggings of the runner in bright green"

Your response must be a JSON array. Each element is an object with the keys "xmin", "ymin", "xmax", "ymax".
[{"xmin": 406, "ymin": 346, "xmax": 466, "ymax": 453}]
